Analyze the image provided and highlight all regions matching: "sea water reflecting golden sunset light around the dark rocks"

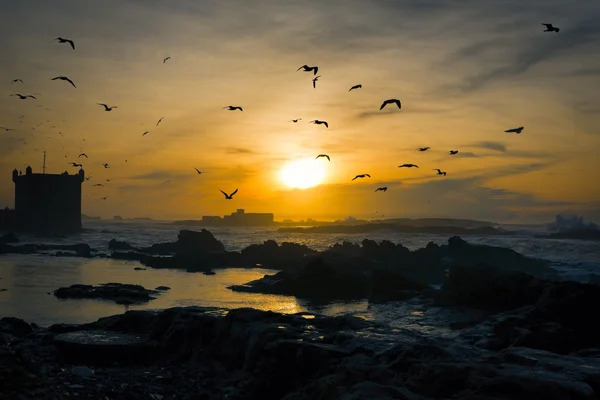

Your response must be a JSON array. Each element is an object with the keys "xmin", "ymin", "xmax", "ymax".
[{"xmin": 0, "ymin": 220, "xmax": 600, "ymax": 333}]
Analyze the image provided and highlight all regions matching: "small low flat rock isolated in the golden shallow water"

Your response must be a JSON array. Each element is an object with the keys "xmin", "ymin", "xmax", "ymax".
[{"xmin": 53, "ymin": 283, "xmax": 159, "ymax": 304}]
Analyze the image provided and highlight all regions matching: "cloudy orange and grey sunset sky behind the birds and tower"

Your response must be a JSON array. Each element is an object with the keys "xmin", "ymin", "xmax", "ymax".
[{"xmin": 0, "ymin": 0, "xmax": 600, "ymax": 223}]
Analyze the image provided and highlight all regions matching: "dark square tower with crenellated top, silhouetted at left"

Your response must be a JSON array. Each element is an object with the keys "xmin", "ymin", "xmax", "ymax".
[{"xmin": 12, "ymin": 159, "xmax": 85, "ymax": 233}]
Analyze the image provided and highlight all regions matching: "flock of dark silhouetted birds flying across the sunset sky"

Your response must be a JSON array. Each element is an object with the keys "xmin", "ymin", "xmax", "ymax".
[{"xmin": 0, "ymin": 23, "xmax": 560, "ymax": 200}]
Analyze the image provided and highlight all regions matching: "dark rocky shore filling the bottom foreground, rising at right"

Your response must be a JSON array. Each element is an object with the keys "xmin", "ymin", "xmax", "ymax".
[{"xmin": 0, "ymin": 266, "xmax": 600, "ymax": 400}]
